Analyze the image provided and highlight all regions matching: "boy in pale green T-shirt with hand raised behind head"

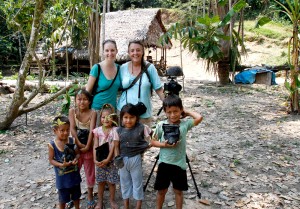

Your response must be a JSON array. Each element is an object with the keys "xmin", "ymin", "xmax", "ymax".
[{"xmin": 151, "ymin": 94, "xmax": 202, "ymax": 209}]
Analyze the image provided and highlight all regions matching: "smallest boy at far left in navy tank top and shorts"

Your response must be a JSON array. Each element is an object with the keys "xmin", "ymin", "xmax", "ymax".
[{"xmin": 48, "ymin": 116, "xmax": 81, "ymax": 209}]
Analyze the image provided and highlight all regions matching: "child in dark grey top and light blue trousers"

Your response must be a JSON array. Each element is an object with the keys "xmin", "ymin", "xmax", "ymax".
[{"xmin": 114, "ymin": 103, "xmax": 152, "ymax": 209}]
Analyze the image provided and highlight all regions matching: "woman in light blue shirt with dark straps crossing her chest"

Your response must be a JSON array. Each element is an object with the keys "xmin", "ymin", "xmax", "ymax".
[{"xmin": 117, "ymin": 40, "xmax": 164, "ymax": 127}]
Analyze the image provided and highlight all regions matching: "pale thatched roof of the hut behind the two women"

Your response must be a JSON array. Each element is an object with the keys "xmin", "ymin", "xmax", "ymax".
[{"xmin": 105, "ymin": 9, "xmax": 171, "ymax": 60}]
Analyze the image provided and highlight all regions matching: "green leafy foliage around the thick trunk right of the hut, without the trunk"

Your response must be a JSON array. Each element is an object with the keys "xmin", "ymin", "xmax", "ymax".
[{"xmin": 160, "ymin": 0, "xmax": 247, "ymax": 83}]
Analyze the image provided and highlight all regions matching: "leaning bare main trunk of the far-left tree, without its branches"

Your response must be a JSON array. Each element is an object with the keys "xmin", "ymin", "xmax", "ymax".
[{"xmin": 0, "ymin": 0, "xmax": 44, "ymax": 130}]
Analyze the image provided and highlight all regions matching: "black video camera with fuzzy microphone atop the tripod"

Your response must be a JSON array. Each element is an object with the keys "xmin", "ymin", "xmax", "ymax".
[{"xmin": 164, "ymin": 66, "xmax": 183, "ymax": 96}]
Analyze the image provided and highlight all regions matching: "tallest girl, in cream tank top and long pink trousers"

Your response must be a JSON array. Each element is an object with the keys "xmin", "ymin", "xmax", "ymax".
[{"xmin": 69, "ymin": 89, "xmax": 97, "ymax": 208}]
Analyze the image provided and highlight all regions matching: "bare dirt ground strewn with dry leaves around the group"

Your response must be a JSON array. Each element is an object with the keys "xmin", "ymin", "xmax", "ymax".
[{"xmin": 0, "ymin": 40, "xmax": 300, "ymax": 209}]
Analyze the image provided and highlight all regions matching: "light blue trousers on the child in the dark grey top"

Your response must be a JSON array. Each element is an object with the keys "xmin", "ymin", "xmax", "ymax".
[{"xmin": 120, "ymin": 155, "xmax": 144, "ymax": 200}]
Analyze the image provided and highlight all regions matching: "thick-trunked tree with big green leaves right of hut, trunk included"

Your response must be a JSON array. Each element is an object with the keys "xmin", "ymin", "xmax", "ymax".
[{"xmin": 161, "ymin": 0, "xmax": 246, "ymax": 84}]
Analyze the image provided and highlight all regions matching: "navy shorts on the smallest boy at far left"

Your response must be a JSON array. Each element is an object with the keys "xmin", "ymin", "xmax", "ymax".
[{"xmin": 58, "ymin": 184, "xmax": 81, "ymax": 203}]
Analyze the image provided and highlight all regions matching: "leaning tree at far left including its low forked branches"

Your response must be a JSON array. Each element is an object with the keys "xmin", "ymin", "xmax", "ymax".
[{"xmin": 0, "ymin": 0, "xmax": 80, "ymax": 130}]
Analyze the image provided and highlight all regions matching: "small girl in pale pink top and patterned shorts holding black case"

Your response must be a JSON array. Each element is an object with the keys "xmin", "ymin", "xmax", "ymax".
[{"xmin": 93, "ymin": 104, "xmax": 119, "ymax": 209}]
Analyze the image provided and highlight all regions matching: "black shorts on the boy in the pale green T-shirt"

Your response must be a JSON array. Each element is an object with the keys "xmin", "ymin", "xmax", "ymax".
[{"xmin": 154, "ymin": 163, "xmax": 188, "ymax": 191}]
